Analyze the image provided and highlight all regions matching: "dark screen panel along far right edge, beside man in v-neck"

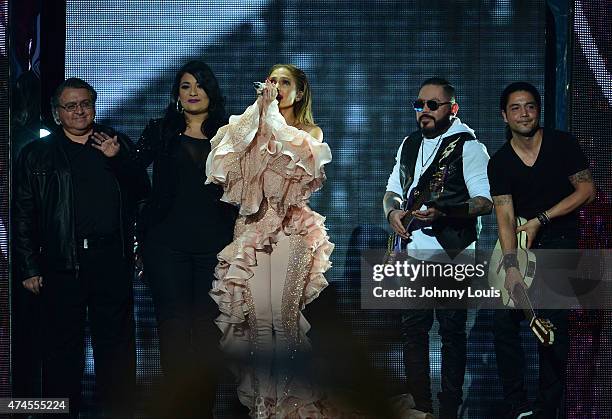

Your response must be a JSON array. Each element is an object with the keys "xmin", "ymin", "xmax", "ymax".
[{"xmin": 568, "ymin": 0, "xmax": 612, "ymax": 418}]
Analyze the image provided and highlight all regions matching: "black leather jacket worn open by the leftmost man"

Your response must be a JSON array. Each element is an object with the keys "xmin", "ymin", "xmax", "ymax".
[{"xmin": 12, "ymin": 125, "xmax": 150, "ymax": 279}]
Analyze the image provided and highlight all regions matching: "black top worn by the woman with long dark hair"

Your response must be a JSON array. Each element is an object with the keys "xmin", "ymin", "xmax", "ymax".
[{"xmin": 149, "ymin": 134, "xmax": 236, "ymax": 253}]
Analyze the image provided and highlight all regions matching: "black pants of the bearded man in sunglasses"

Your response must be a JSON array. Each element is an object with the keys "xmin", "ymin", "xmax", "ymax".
[{"xmin": 402, "ymin": 309, "xmax": 467, "ymax": 418}]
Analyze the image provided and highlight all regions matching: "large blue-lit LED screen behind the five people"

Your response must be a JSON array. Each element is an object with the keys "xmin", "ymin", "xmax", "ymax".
[{"xmin": 66, "ymin": 0, "xmax": 545, "ymax": 418}]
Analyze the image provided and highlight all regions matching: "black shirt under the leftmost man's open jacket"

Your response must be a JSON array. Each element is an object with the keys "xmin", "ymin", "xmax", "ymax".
[{"xmin": 64, "ymin": 136, "xmax": 120, "ymax": 238}]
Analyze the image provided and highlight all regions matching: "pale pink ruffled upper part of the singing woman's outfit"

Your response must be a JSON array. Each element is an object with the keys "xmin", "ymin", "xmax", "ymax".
[{"xmin": 206, "ymin": 101, "xmax": 331, "ymax": 216}]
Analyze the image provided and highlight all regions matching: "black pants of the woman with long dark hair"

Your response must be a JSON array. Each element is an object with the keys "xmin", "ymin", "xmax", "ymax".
[{"xmin": 144, "ymin": 241, "xmax": 221, "ymax": 418}]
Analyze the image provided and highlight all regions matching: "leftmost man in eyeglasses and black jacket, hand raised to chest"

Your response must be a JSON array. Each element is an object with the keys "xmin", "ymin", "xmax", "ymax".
[{"xmin": 13, "ymin": 78, "xmax": 150, "ymax": 418}]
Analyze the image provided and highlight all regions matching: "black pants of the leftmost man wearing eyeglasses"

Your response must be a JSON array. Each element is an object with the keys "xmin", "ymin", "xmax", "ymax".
[{"xmin": 41, "ymin": 241, "xmax": 136, "ymax": 418}]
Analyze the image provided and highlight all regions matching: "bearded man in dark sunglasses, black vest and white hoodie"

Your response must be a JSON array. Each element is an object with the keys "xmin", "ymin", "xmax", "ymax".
[{"xmin": 383, "ymin": 77, "xmax": 492, "ymax": 419}]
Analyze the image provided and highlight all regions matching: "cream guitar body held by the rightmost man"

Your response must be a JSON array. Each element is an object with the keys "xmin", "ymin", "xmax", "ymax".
[{"xmin": 489, "ymin": 217, "xmax": 536, "ymax": 308}]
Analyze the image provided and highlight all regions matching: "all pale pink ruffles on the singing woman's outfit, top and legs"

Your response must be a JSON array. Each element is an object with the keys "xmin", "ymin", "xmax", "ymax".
[{"xmin": 206, "ymin": 98, "xmax": 334, "ymax": 417}]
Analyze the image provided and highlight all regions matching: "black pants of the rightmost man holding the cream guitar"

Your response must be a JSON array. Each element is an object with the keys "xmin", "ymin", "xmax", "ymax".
[{"xmin": 493, "ymin": 230, "xmax": 576, "ymax": 418}]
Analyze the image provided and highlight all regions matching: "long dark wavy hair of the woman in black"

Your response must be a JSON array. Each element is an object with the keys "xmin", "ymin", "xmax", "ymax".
[{"xmin": 162, "ymin": 60, "xmax": 228, "ymax": 143}]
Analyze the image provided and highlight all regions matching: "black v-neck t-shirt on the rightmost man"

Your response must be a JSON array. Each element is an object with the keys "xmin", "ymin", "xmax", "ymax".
[{"xmin": 488, "ymin": 129, "xmax": 589, "ymax": 228}]
